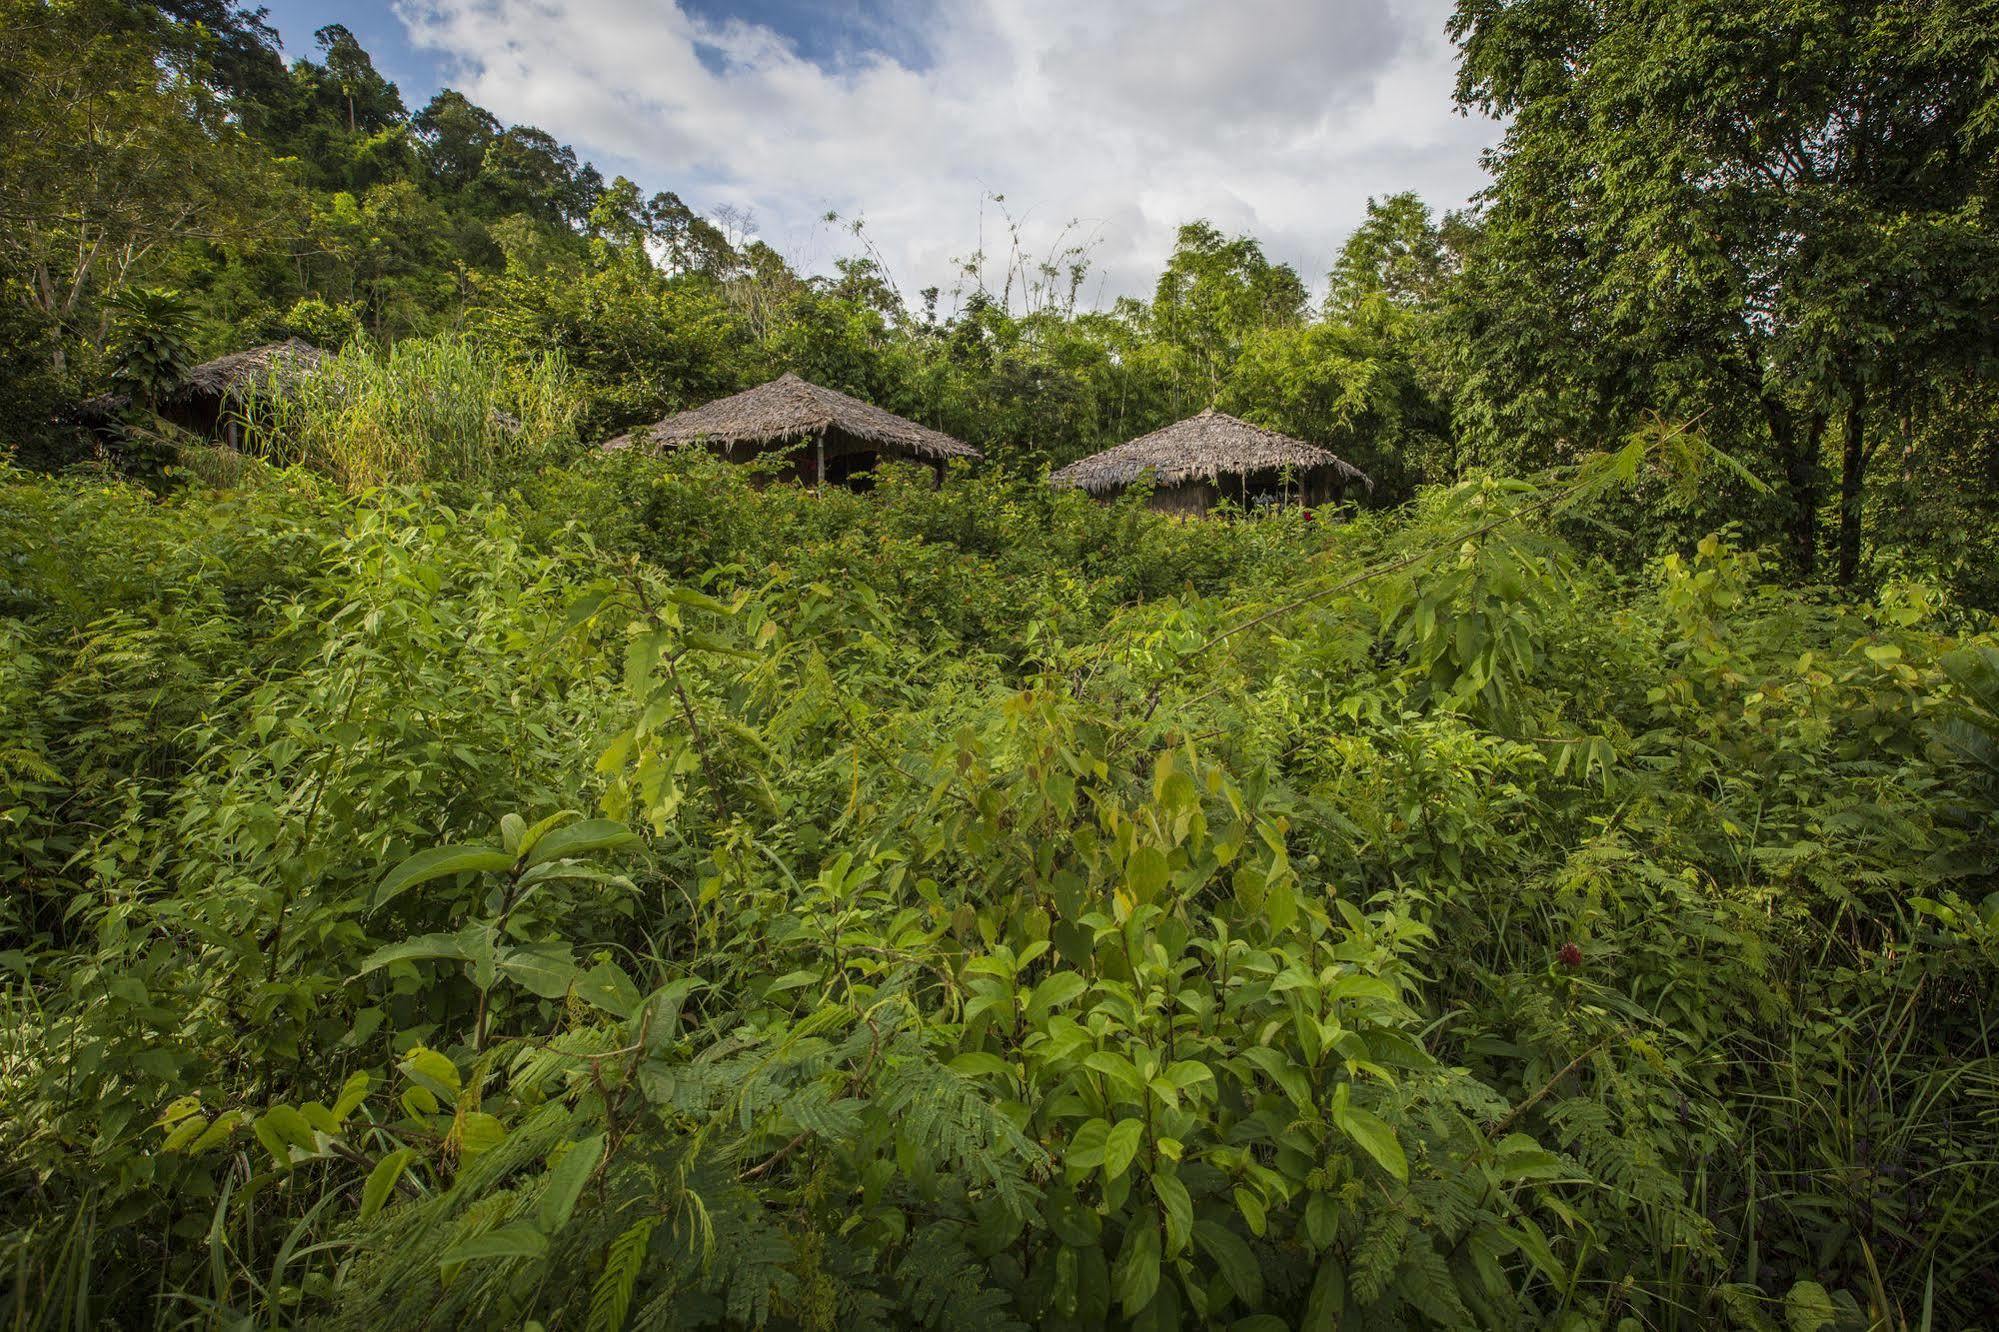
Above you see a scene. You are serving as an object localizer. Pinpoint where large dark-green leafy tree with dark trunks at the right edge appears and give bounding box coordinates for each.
[1451,0,1999,580]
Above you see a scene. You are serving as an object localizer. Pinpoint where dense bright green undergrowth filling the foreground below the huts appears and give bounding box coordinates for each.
[0,434,1999,1332]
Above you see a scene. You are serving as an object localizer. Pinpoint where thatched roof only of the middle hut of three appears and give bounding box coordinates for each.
[604,374,982,460]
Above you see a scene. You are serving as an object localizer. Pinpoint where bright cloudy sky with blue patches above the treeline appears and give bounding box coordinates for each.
[257,0,1495,302]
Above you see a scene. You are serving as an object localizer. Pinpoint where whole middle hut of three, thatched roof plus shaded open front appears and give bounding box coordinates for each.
[604,374,982,488]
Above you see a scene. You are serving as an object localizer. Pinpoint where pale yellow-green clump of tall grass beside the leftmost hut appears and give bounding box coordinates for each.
[242,336,576,490]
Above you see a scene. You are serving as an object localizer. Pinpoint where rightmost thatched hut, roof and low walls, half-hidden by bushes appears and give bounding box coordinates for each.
[1047,408,1373,514]
